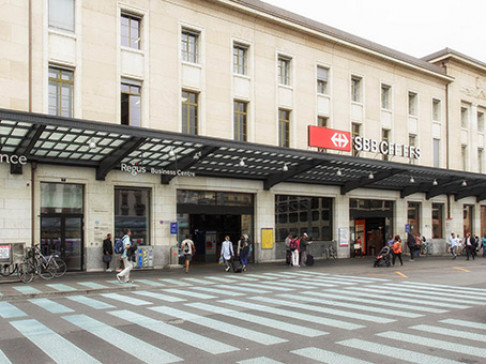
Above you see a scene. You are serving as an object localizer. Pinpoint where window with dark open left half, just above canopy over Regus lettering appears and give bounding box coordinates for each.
[121,80,142,126]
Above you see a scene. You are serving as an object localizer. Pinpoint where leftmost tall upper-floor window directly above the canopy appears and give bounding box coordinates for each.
[48,67,74,118]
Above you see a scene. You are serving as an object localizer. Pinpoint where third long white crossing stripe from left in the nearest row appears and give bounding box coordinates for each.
[110,310,240,354]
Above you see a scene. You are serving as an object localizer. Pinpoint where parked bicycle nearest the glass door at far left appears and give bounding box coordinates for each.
[17,245,67,283]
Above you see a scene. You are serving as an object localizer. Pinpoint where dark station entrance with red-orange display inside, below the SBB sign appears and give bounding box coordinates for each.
[349,199,394,256]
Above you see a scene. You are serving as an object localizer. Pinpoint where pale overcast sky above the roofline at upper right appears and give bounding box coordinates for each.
[264,0,486,63]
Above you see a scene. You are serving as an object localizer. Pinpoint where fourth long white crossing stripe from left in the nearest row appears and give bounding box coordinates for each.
[149,306,287,345]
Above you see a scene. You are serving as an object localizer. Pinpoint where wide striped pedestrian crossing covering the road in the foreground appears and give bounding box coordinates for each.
[0,271,486,364]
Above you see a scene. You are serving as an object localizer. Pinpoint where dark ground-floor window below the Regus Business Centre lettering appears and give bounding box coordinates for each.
[115,187,150,245]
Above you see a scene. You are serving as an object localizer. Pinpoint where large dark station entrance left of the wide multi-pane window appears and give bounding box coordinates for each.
[177,190,254,263]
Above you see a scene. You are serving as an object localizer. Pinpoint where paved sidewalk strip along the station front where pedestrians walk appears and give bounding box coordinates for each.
[0,256,486,301]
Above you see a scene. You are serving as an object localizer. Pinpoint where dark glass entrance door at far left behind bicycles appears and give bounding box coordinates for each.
[41,214,84,271]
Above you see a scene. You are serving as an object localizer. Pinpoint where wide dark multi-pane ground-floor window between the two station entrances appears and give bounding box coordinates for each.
[275,195,333,242]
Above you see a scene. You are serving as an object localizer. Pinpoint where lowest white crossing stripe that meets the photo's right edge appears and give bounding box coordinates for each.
[376,331,486,359]
